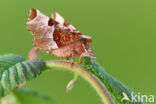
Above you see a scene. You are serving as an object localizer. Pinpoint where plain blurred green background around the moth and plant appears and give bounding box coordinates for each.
[0,0,156,104]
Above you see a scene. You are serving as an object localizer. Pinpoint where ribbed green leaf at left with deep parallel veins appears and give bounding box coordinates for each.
[0,54,44,97]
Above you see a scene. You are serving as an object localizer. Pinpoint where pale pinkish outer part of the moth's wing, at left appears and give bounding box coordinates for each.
[26,9,58,52]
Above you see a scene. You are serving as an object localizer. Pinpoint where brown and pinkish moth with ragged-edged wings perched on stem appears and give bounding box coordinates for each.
[26,9,93,59]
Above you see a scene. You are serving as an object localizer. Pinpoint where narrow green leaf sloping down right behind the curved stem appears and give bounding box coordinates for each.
[81,57,143,104]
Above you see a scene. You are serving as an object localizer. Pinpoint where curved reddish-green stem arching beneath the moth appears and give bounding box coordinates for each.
[46,61,113,104]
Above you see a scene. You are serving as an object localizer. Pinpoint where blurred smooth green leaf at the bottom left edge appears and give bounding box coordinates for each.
[1,89,53,104]
